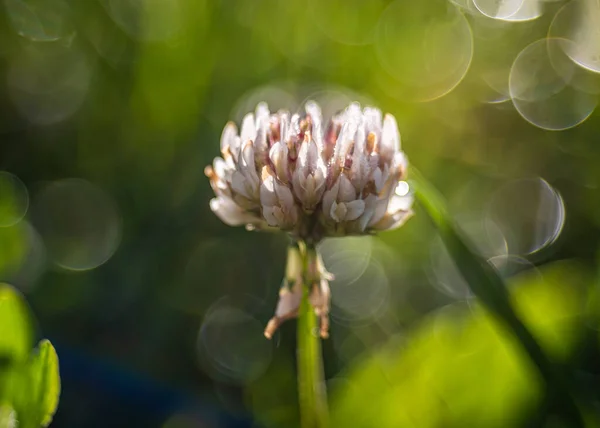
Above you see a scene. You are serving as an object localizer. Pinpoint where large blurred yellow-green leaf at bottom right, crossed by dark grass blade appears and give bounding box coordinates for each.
[332,262,587,428]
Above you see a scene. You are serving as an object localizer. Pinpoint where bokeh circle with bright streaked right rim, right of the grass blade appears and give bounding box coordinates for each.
[486,178,566,256]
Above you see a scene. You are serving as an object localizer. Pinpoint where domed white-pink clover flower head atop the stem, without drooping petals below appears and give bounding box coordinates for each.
[205,101,412,242]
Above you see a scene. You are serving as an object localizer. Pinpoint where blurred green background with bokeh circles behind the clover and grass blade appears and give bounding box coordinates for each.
[0,0,600,428]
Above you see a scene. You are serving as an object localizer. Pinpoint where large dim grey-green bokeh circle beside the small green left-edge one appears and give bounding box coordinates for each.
[32,178,121,270]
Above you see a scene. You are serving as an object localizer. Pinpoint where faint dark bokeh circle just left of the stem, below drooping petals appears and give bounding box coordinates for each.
[197,297,273,384]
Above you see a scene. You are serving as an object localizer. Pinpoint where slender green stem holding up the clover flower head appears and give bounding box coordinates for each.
[297,245,327,428]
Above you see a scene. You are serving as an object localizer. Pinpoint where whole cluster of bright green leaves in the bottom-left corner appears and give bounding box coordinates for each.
[0,284,60,428]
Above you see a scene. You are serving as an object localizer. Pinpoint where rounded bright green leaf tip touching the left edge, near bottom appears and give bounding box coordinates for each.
[0,283,33,362]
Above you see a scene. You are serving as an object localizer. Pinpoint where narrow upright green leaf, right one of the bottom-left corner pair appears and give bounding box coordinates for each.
[28,339,60,427]
